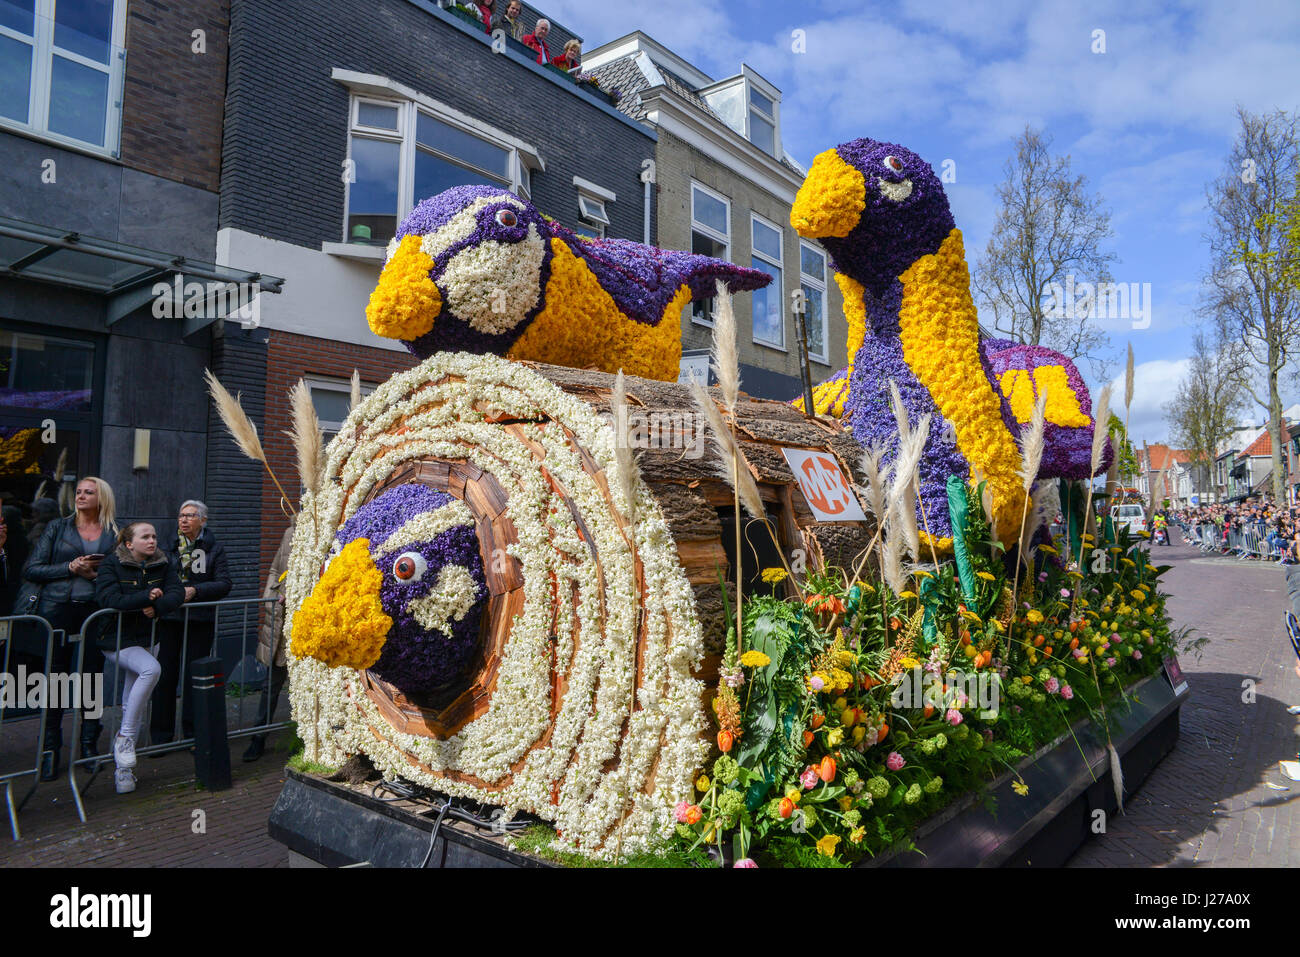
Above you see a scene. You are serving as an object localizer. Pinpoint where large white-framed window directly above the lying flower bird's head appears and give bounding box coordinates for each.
[343,92,536,246]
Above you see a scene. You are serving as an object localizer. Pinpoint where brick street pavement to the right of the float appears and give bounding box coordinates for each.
[1067,531,1300,867]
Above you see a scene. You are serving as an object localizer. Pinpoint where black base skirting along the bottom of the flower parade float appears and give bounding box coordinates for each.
[268,674,1188,867]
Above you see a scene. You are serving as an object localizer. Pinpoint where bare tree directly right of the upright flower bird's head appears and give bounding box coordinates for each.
[974,126,1115,365]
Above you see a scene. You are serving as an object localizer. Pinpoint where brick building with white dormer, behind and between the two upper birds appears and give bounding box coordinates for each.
[582,31,848,399]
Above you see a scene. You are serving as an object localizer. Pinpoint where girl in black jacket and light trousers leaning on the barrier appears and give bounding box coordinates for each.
[95,521,185,794]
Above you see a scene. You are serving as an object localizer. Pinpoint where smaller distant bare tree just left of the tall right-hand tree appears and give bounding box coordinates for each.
[1165,332,1248,489]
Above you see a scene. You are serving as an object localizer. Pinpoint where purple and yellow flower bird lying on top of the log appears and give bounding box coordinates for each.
[365,186,771,381]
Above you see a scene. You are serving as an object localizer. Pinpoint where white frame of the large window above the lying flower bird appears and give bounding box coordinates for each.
[335,87,543,243]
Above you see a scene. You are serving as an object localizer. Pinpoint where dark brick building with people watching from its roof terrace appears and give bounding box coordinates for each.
[217,0,655,595]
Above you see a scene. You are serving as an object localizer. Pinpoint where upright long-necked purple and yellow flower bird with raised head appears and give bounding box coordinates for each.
[790,139,1107,549]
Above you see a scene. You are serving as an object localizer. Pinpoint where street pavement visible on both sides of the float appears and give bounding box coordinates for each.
[0,533,1300,867]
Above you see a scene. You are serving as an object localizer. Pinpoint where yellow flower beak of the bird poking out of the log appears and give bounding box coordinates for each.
[289,538,393,670]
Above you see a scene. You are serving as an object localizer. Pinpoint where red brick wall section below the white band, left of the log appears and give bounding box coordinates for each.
[260,330,417,577]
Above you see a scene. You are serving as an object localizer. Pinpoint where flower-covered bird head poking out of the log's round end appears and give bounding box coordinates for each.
[291,484,488,701]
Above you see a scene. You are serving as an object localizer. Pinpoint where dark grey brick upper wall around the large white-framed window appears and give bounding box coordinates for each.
[221,0,654,248]
